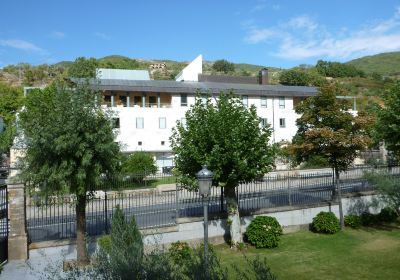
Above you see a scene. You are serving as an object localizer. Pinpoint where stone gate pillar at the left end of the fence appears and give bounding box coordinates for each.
[7,179,28,260]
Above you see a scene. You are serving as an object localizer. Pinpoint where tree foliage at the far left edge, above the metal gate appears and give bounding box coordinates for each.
[0,83,23,155]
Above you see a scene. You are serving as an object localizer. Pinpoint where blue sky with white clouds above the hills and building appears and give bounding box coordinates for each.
[0,0,400,68]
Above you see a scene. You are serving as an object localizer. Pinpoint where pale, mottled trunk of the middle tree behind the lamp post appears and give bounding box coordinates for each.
[224,186,243,246]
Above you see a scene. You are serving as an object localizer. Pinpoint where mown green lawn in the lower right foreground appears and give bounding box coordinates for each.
[216,227,400,280]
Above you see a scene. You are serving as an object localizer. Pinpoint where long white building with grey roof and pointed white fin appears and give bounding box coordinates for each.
[86,56,317,169]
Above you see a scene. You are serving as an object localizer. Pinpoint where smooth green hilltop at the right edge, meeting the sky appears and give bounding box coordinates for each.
[347,52,400,76]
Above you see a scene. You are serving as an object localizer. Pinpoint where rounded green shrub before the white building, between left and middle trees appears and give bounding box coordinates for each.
[121,151,157,176]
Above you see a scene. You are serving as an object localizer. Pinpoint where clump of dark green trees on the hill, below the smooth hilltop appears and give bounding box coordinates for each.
[315,60,365,78]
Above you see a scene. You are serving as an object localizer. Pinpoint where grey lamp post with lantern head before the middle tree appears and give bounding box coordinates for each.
[196,165,214,274]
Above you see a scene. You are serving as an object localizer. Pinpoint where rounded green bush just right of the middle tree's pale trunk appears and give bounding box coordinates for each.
[245,216,282,248]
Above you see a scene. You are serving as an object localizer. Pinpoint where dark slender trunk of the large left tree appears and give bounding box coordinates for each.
[76,195,89,264]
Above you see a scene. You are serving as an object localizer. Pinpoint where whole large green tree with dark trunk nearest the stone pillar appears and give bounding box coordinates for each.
[20,84,119,262]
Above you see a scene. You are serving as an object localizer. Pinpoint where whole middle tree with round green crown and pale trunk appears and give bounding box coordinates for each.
[171,93,274,244]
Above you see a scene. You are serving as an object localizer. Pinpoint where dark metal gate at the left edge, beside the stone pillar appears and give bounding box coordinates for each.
[0,185,8,264]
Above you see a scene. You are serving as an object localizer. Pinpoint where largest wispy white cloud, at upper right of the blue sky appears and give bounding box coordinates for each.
[244,7,400,60]
